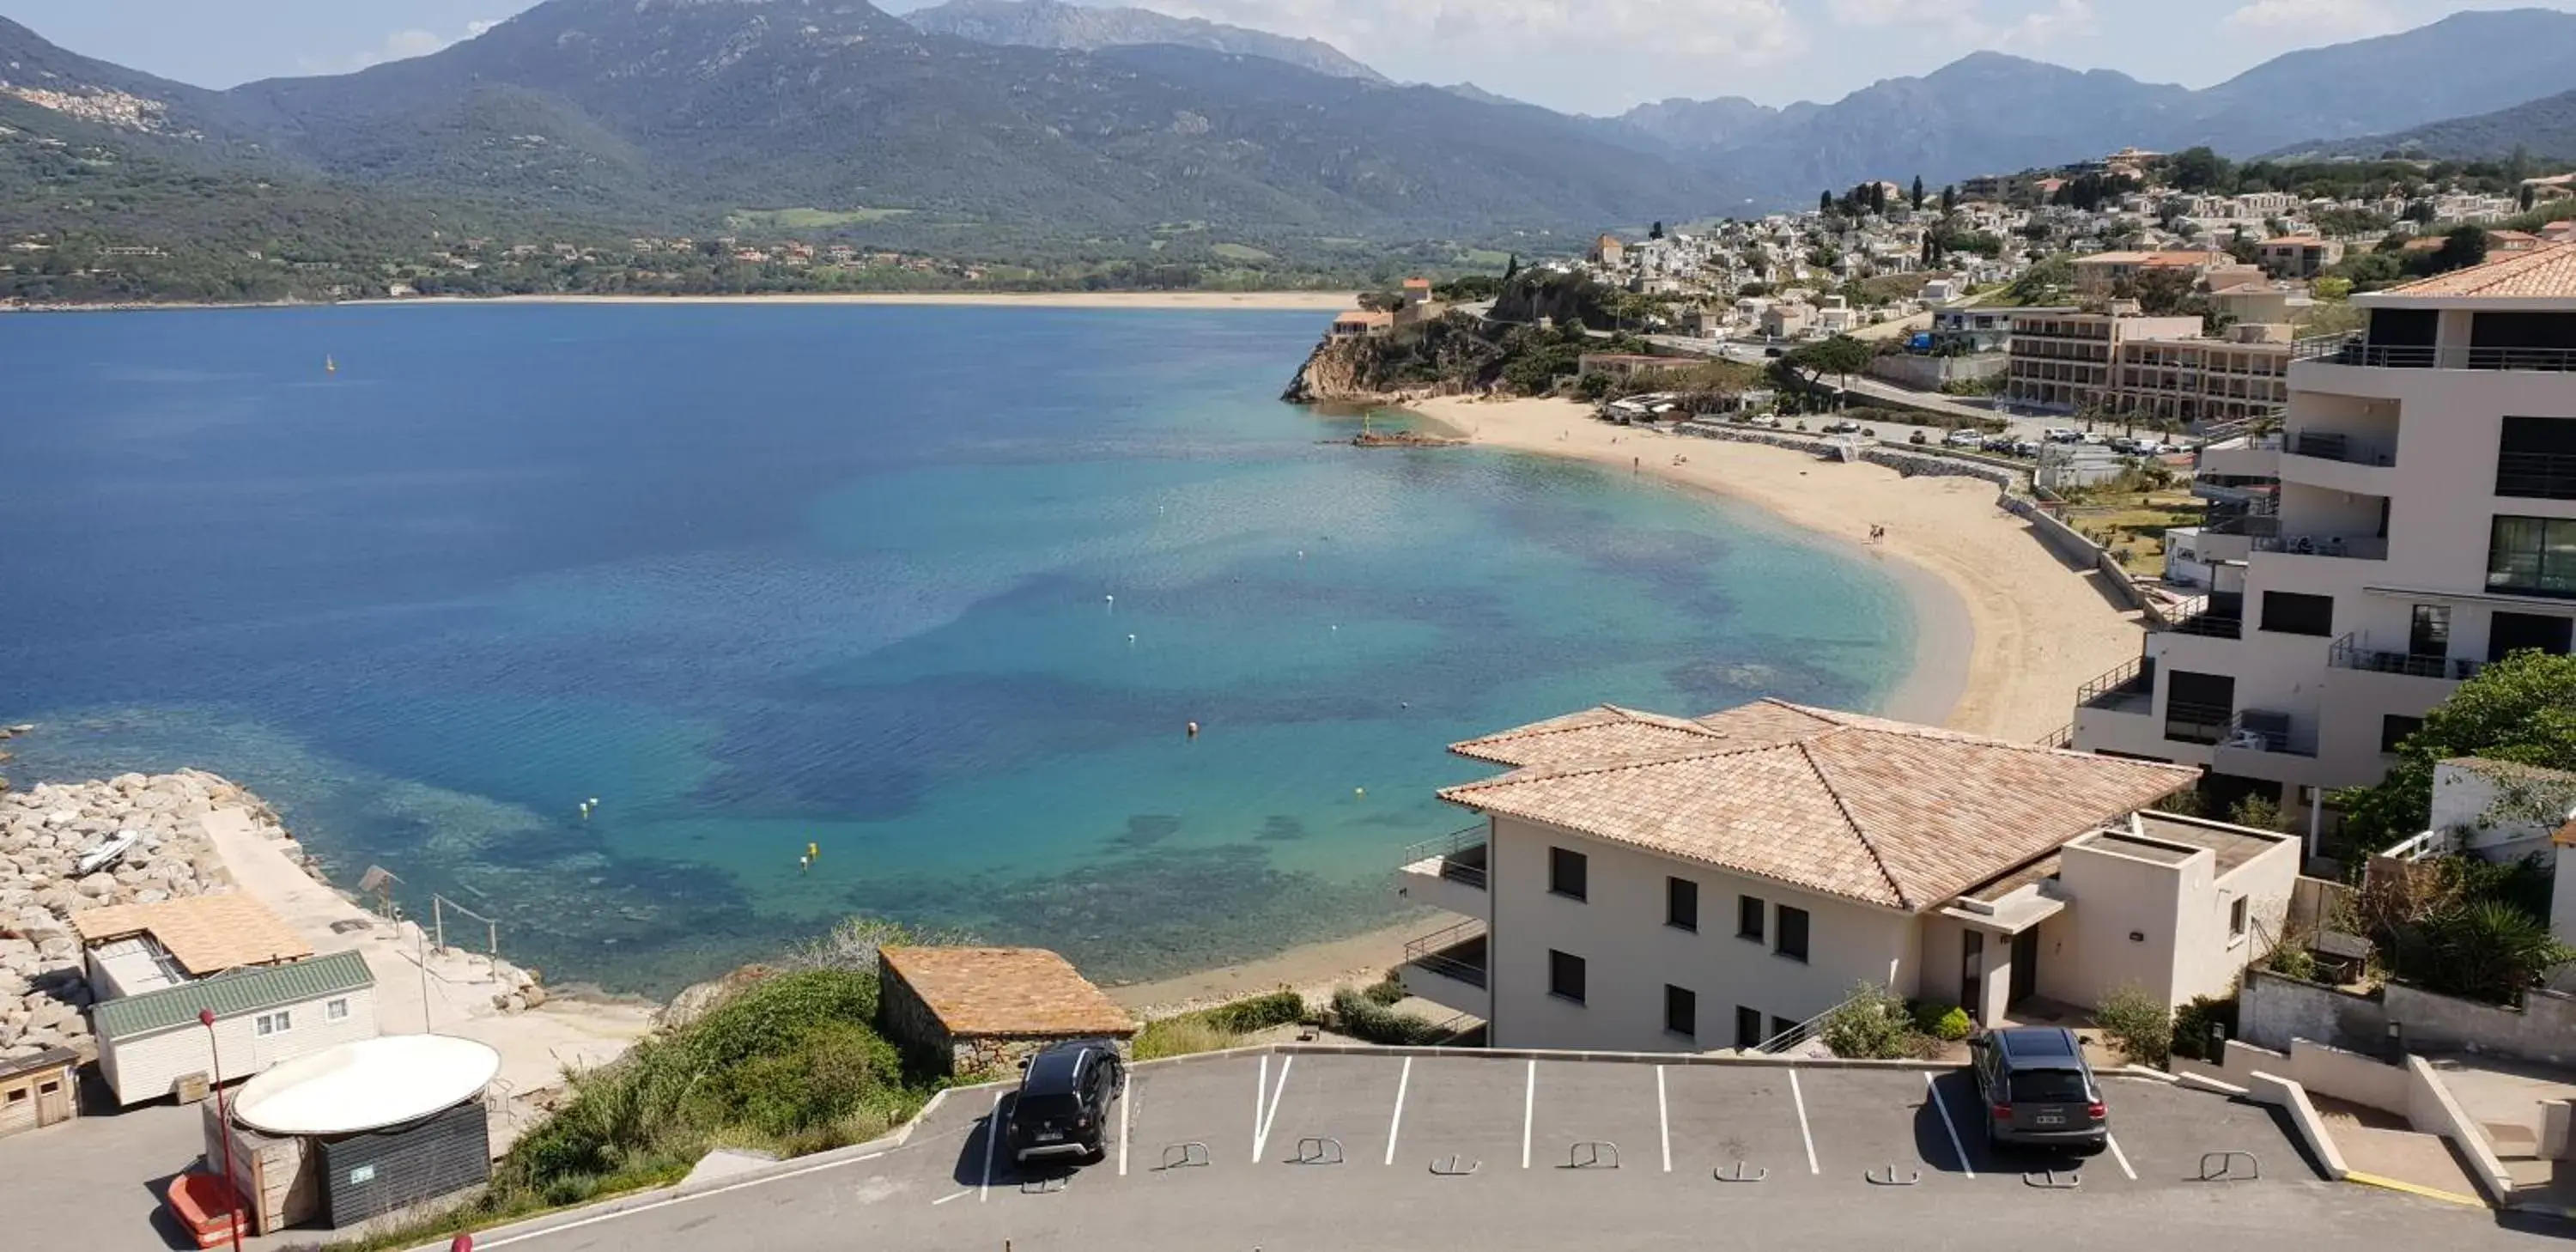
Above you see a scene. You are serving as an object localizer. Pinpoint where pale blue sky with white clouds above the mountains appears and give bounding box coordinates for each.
[0,0,2576,113]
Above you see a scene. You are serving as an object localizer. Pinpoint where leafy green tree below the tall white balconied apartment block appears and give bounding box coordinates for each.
[2334,652,2576,848]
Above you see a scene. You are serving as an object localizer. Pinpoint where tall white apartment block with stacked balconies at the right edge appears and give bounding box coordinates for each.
[2074,245,2576,806]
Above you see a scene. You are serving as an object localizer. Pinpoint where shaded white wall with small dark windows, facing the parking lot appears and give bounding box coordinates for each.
[1486,817,1917,1051]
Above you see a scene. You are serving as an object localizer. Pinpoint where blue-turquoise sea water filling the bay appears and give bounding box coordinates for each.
[0,307,1911,992]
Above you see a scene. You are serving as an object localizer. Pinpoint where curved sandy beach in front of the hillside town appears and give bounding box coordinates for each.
[1417,397,2143,739]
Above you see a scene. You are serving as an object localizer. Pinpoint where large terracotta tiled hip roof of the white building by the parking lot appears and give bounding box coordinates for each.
[1440,701,2197,912]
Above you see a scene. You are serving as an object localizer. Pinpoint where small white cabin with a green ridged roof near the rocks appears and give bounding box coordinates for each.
[90,953,376,1105]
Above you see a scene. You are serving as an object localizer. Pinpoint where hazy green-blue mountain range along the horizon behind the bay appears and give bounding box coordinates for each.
[0,0,2576,266]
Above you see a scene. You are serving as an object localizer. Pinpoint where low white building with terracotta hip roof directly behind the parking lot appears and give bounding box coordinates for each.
[1396,701,2298,1051]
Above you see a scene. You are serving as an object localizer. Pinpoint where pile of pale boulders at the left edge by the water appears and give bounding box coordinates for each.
[0,770,258,1059]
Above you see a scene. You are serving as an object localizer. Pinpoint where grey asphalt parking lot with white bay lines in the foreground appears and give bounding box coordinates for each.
[482,1051,2555,1252]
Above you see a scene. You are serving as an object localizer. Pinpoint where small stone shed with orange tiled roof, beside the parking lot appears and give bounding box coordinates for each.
[876,948,1136,1074]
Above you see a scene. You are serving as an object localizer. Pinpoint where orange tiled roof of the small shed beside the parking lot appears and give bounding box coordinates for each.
[876,948,1136,1038]
